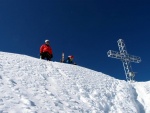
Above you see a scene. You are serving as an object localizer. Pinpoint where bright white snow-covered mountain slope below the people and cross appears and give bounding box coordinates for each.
[0,52,150,113]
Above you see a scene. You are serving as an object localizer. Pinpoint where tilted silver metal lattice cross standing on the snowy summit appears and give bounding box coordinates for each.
[107,39,141,81]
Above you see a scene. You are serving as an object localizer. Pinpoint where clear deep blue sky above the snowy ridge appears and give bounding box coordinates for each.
[0,0,150,81]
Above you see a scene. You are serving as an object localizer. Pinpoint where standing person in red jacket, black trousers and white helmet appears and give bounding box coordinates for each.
[40,40,53,61]
